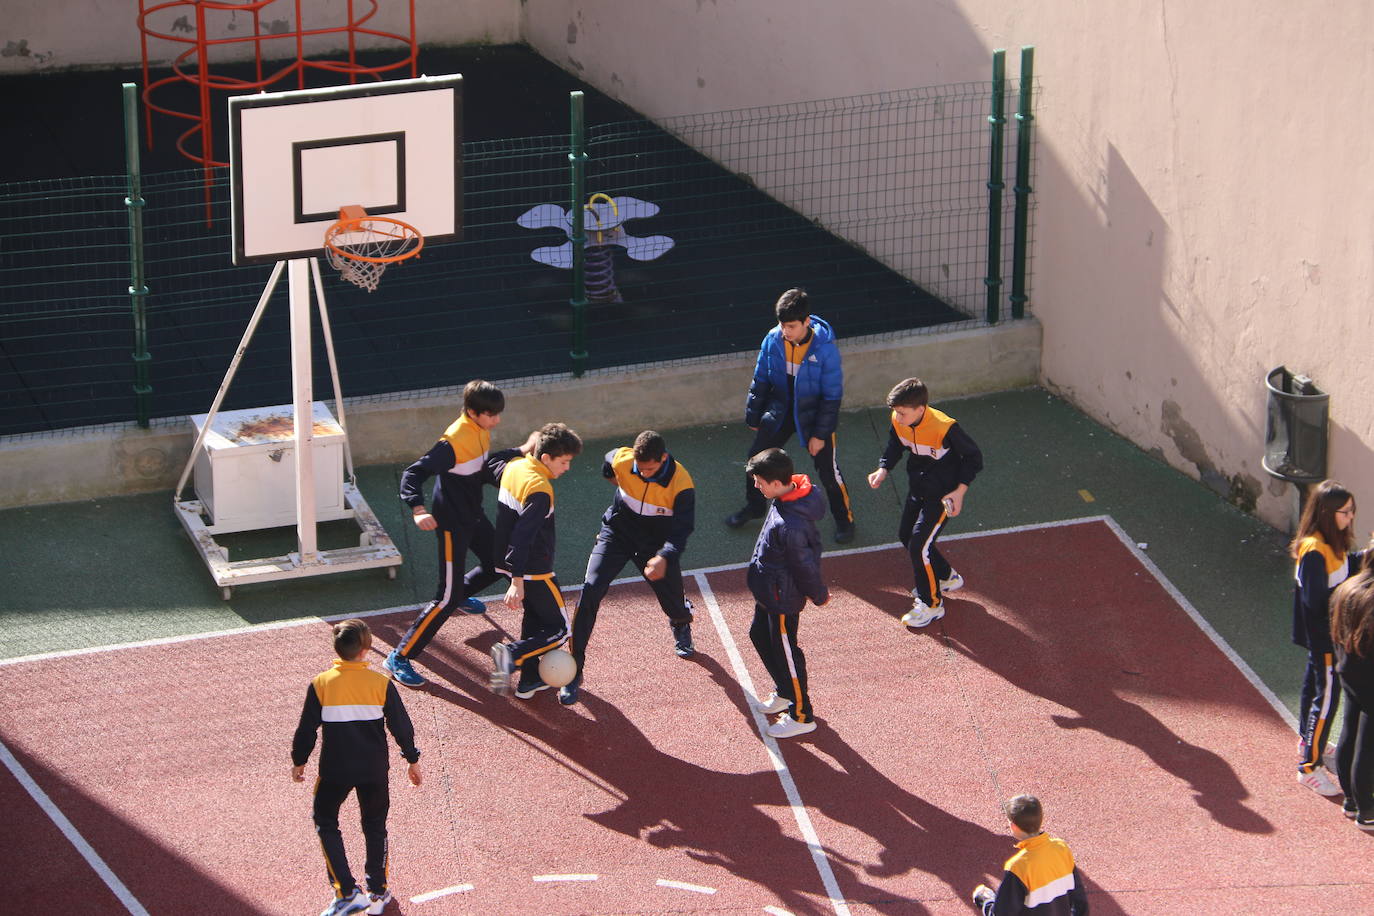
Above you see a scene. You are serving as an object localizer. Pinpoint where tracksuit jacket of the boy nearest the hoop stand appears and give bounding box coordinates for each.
[401,411,518,530]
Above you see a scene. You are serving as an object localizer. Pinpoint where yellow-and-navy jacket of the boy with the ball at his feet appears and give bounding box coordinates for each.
[493,455,554,578]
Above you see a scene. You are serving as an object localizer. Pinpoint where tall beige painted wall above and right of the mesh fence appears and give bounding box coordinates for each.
[523,0,1374,533]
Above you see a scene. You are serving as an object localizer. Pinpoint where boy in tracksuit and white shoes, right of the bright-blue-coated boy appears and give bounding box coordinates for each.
[868,379,982,626]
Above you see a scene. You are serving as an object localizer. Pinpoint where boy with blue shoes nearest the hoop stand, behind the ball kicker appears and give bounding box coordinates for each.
[383,379,529,687]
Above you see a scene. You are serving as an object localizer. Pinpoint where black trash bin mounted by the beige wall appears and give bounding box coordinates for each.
[1263,365,1330,483]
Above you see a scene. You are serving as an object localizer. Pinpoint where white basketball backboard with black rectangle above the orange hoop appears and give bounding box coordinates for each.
[229,74,463,264]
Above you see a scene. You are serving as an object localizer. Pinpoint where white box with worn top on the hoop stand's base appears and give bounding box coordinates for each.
[191,401,352,534]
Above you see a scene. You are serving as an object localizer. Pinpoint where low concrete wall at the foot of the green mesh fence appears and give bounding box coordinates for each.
[0,320,1040,508]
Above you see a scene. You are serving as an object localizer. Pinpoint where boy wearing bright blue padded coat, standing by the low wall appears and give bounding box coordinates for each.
[725,288,855,544]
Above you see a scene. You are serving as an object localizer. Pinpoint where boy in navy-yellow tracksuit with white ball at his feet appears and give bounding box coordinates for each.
[491,423,583,699]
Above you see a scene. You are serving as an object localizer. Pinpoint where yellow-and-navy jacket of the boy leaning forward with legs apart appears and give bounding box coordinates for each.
[602,448,697,559]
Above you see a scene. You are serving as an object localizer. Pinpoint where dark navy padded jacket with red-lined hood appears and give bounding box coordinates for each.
[749,474,830,614]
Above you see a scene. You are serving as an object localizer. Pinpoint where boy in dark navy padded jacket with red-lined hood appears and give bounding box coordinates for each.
[745,449,830,737]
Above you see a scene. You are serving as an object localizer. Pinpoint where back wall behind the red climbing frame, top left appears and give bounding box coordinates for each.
[0,0,522,76]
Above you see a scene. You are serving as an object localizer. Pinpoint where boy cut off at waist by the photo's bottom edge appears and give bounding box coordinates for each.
[973,795,1088,916]
